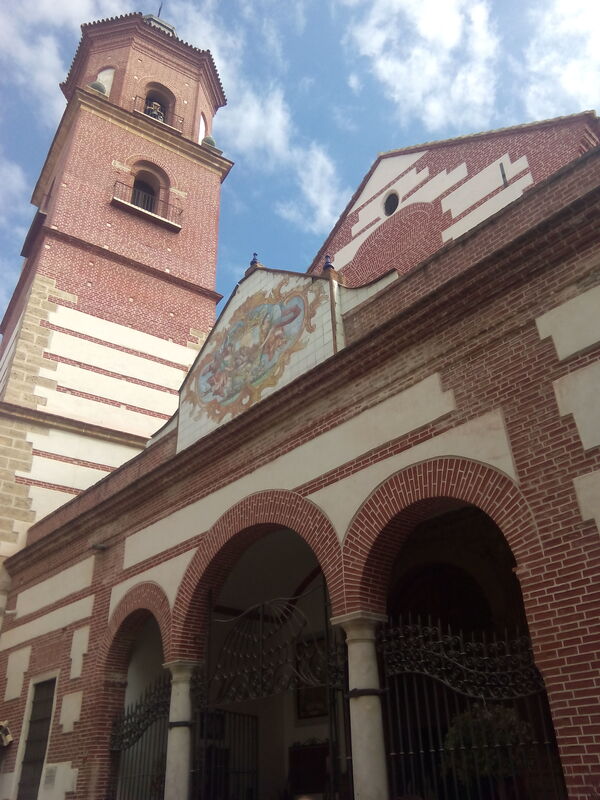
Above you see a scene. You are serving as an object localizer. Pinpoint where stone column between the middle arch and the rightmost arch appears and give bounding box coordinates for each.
[331,611,389,800]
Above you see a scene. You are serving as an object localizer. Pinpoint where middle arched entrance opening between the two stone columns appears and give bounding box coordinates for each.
[192,530,351,800]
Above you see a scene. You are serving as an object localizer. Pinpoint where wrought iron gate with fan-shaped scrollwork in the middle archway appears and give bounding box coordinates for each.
[191,595,351,800]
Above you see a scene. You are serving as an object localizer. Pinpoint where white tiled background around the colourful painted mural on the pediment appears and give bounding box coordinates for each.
[177,269,334,451]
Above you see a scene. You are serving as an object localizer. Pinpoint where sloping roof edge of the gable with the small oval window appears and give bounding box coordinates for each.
[307,109,600,274]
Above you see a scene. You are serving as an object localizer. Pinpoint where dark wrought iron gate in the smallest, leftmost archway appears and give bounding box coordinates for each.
[108,675,171,800]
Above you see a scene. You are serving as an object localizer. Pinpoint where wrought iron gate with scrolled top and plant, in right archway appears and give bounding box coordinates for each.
[379,621,567,800]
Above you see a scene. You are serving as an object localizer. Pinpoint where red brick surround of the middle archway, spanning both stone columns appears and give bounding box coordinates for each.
[172,489,343,659]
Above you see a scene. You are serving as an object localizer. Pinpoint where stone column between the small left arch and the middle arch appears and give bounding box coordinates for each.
[163,661,198,800]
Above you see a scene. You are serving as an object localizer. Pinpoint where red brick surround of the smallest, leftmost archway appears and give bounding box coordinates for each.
[97,582,171,675]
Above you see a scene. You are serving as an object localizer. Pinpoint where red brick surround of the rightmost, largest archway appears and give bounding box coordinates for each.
[342,457,542,613]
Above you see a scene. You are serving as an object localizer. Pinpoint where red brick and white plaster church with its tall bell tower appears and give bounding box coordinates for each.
[0,14,600,800]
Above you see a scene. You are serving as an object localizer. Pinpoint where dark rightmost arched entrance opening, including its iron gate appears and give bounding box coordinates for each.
[379,506,567,800]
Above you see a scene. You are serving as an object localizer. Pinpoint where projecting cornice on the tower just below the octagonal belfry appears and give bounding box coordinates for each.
[31,89,233,208]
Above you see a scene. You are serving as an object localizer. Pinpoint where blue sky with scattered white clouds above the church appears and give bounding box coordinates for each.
[0,0,600,313]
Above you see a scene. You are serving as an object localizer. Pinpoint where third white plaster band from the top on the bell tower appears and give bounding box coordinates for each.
[40,363,179,414]
